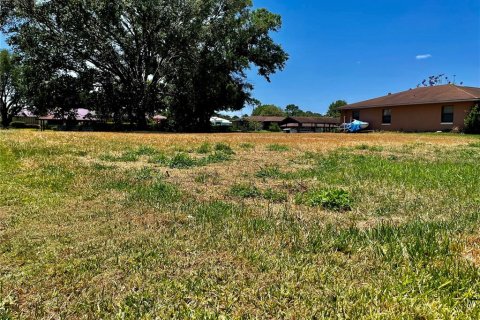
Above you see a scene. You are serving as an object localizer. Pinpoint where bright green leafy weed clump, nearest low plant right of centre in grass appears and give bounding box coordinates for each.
[296,189,352,211]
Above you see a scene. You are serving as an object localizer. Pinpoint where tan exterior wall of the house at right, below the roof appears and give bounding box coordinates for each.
[341,102,475,132]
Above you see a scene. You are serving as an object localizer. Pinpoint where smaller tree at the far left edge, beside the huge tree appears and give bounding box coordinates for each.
[0,50,23,128]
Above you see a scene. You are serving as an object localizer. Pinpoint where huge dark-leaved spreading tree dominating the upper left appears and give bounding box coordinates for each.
[0,0,288,131]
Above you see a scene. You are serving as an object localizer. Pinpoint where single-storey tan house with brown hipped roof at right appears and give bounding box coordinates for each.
[339,84,480,132]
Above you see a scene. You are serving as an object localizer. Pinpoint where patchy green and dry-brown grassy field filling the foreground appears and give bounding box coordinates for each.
[0,130,480,319]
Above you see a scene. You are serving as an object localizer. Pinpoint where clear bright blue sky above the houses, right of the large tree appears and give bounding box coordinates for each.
[0,0,480,112]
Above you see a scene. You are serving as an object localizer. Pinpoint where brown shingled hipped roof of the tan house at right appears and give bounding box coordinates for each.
[338,84,480,110]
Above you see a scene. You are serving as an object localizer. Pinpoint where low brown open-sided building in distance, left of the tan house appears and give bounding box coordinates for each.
[280,117,340,133]
